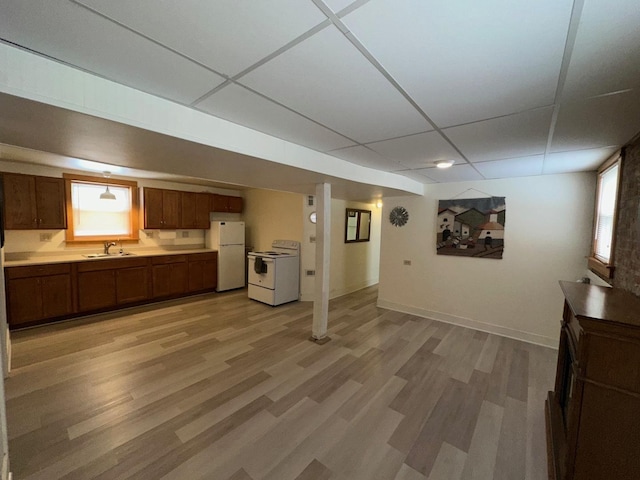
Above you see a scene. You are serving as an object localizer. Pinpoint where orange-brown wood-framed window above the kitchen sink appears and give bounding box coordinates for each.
[65,175,138,242]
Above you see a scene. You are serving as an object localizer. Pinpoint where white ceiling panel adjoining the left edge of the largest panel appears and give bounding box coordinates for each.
[240,26,429,143]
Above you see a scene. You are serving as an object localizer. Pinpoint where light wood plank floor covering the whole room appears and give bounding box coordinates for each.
[6,287,556,480]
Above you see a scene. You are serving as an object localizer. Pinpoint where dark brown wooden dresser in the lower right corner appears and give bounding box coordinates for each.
[546,282,640,480]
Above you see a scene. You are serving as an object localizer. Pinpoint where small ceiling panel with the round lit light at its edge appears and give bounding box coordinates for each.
[367,132,464,168]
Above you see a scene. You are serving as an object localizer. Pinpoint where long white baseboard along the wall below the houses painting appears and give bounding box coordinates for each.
[377,298,559,350]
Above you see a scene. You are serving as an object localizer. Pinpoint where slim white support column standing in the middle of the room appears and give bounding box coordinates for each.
[309,183,331,344]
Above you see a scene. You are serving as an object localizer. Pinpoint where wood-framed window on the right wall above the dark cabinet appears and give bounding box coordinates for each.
[589,154,620,279]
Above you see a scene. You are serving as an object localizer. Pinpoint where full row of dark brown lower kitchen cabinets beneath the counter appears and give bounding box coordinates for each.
[5,252,218,328]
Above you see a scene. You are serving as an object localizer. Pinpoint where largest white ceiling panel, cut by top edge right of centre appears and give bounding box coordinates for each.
[343,0,573,127]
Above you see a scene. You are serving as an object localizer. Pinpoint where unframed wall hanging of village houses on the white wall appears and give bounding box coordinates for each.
[436,197,506,259]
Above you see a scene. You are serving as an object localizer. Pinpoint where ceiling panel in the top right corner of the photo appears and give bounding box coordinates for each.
[563,0,640,99]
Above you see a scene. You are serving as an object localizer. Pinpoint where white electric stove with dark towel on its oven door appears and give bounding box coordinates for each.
[247,240,300,306]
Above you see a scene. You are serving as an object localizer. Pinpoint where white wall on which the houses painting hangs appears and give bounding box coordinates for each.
[378,173,595,347]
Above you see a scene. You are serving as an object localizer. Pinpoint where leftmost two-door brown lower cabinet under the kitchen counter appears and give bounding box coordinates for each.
[5,263,73,327]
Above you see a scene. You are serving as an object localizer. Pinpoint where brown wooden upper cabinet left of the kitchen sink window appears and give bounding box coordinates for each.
[3,173,67,230]
